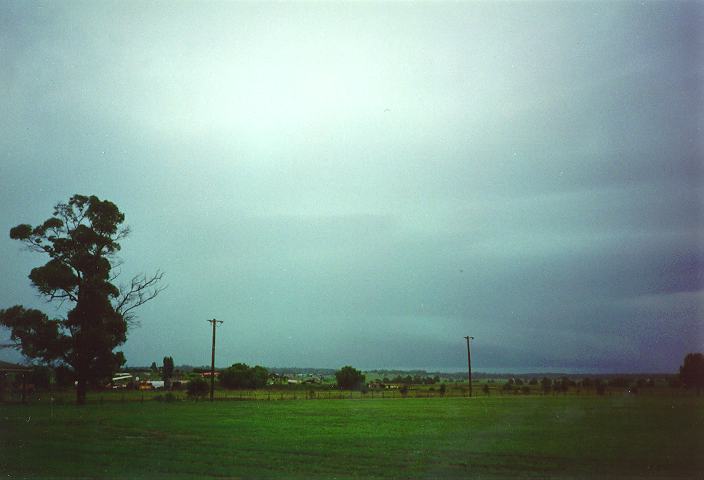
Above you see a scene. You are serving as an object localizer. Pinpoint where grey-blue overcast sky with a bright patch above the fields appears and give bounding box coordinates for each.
[0,1,704,372]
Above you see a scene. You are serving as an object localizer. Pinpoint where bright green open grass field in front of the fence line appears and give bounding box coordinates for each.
[0,396,704,478]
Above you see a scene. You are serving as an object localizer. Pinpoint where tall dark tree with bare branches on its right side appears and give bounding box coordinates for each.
[0,195,163,404]
